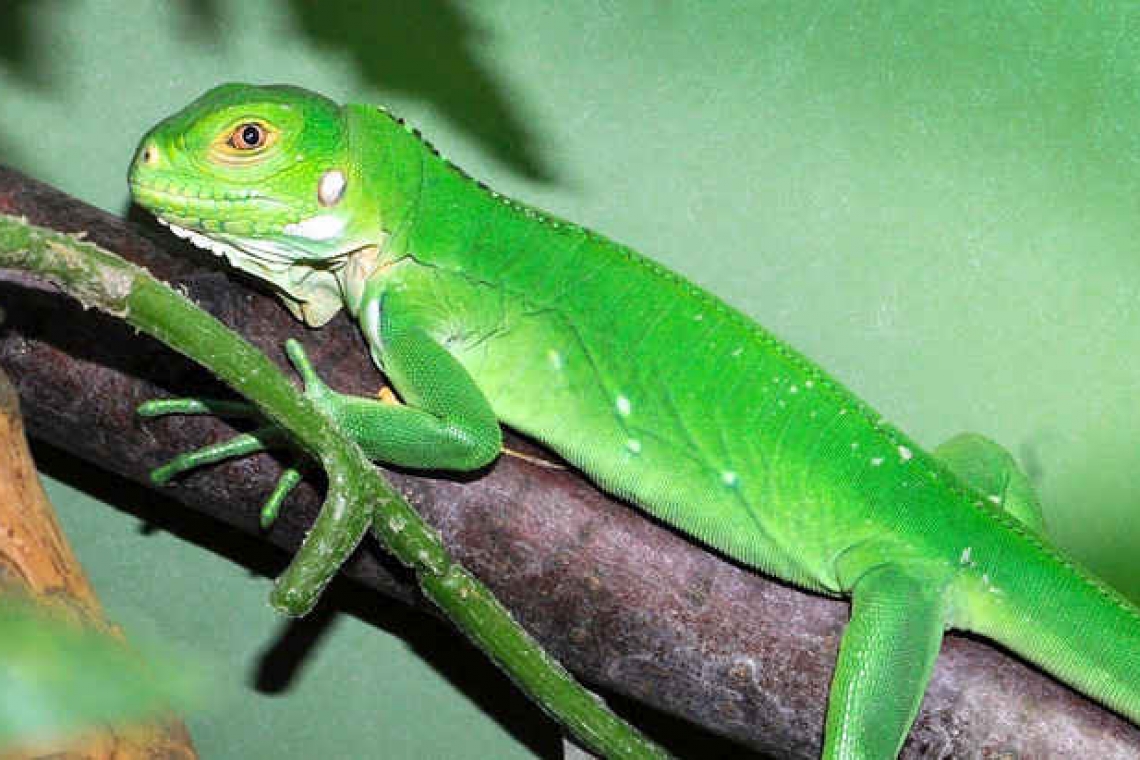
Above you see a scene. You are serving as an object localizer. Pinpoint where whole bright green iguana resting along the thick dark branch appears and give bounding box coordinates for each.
[130,84,1140,758]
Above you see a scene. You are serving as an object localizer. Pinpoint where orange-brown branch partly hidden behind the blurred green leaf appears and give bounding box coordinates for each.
[0,373,197,760]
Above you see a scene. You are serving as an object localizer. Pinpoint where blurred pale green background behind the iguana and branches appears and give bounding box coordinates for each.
[0,0,1140,759]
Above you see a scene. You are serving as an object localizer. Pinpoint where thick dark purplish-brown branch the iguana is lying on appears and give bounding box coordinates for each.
[0,170,1140,758]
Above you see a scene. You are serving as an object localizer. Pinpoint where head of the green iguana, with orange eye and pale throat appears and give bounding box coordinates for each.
[129,84,381,325]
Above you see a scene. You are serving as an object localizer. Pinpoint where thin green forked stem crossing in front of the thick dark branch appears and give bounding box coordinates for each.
[0,214,668,758]
